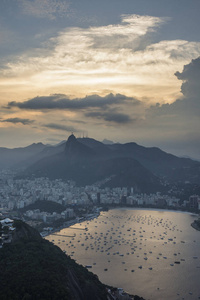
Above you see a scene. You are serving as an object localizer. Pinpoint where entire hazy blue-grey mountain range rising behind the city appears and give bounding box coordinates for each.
[1,135,200,193]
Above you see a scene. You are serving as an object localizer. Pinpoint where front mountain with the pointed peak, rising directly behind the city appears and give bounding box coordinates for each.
[17,135,161,192]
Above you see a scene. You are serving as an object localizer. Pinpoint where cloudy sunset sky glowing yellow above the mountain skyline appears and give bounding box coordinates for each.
[0,0,200,159]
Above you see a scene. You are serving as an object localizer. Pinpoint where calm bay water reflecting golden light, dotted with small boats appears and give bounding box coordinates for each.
[47,208,200,300]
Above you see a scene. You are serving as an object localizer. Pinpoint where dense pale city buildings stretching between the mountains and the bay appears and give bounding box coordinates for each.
[0,170,200,233]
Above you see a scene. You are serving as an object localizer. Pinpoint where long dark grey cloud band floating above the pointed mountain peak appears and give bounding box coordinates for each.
[7,93,141,125]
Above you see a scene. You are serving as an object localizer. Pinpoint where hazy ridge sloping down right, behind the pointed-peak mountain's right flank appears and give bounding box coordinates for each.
[106,143,200,183]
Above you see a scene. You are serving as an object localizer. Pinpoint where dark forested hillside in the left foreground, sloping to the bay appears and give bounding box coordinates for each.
[0,220,111,300]
